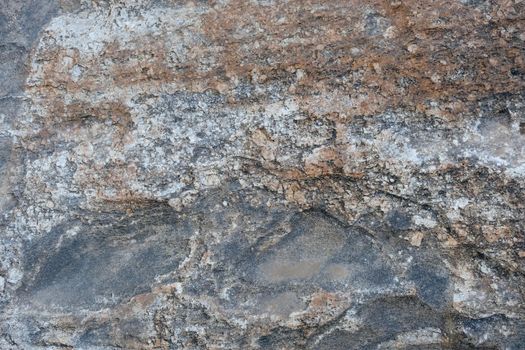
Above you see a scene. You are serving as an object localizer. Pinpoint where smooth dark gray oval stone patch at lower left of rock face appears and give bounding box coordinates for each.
[23,205,192,309]
